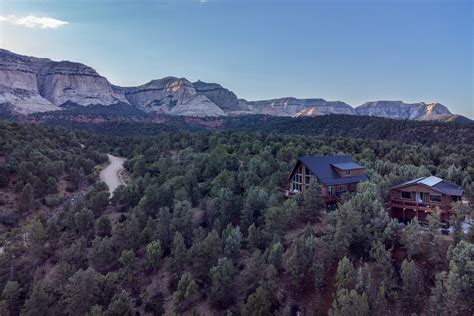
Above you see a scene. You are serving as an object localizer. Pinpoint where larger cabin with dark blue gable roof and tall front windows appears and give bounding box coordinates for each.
[284,155,367,208]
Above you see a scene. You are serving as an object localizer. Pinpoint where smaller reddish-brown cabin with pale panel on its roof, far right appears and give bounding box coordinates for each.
[388,176,464,223]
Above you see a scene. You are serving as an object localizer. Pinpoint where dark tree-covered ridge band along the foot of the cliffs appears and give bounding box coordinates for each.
[20,110,474,145]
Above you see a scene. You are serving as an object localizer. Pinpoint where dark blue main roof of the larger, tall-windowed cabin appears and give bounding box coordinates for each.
[291,155,367,185]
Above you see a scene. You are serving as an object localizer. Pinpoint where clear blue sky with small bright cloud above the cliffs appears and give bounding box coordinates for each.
[0,0,474,118]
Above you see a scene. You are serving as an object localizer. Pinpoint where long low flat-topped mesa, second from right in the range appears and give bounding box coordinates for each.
[247,97,355,117]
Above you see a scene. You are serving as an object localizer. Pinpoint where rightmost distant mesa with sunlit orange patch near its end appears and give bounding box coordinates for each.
[356,101,452,120]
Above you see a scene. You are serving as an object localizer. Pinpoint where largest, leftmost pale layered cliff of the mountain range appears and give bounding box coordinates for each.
[0,49,128,114]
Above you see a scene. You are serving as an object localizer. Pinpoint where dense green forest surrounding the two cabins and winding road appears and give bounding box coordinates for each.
[0,116,474,316]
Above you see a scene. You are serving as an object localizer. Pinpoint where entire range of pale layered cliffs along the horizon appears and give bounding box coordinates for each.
[0,49,469,121]
